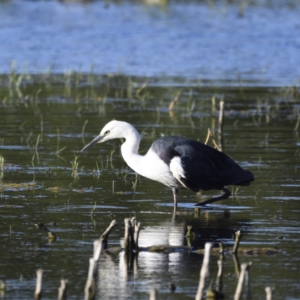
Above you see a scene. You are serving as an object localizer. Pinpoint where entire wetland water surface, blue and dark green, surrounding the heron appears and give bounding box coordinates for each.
[0,0,300,300]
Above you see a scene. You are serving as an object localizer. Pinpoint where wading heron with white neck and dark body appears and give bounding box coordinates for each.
[81,121,254,211]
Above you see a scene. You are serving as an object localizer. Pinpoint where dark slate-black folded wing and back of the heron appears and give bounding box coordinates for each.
[152,136,254,192]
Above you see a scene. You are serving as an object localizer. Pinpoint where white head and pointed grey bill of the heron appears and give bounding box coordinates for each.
[80,120,135,152]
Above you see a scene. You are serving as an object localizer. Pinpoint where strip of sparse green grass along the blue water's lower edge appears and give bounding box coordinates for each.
[0,68,300,132]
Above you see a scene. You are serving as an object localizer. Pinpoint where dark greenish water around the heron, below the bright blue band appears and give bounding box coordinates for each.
[0,77,300,299]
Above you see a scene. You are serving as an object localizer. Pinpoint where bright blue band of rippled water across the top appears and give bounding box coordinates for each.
[0,0,300,86]
